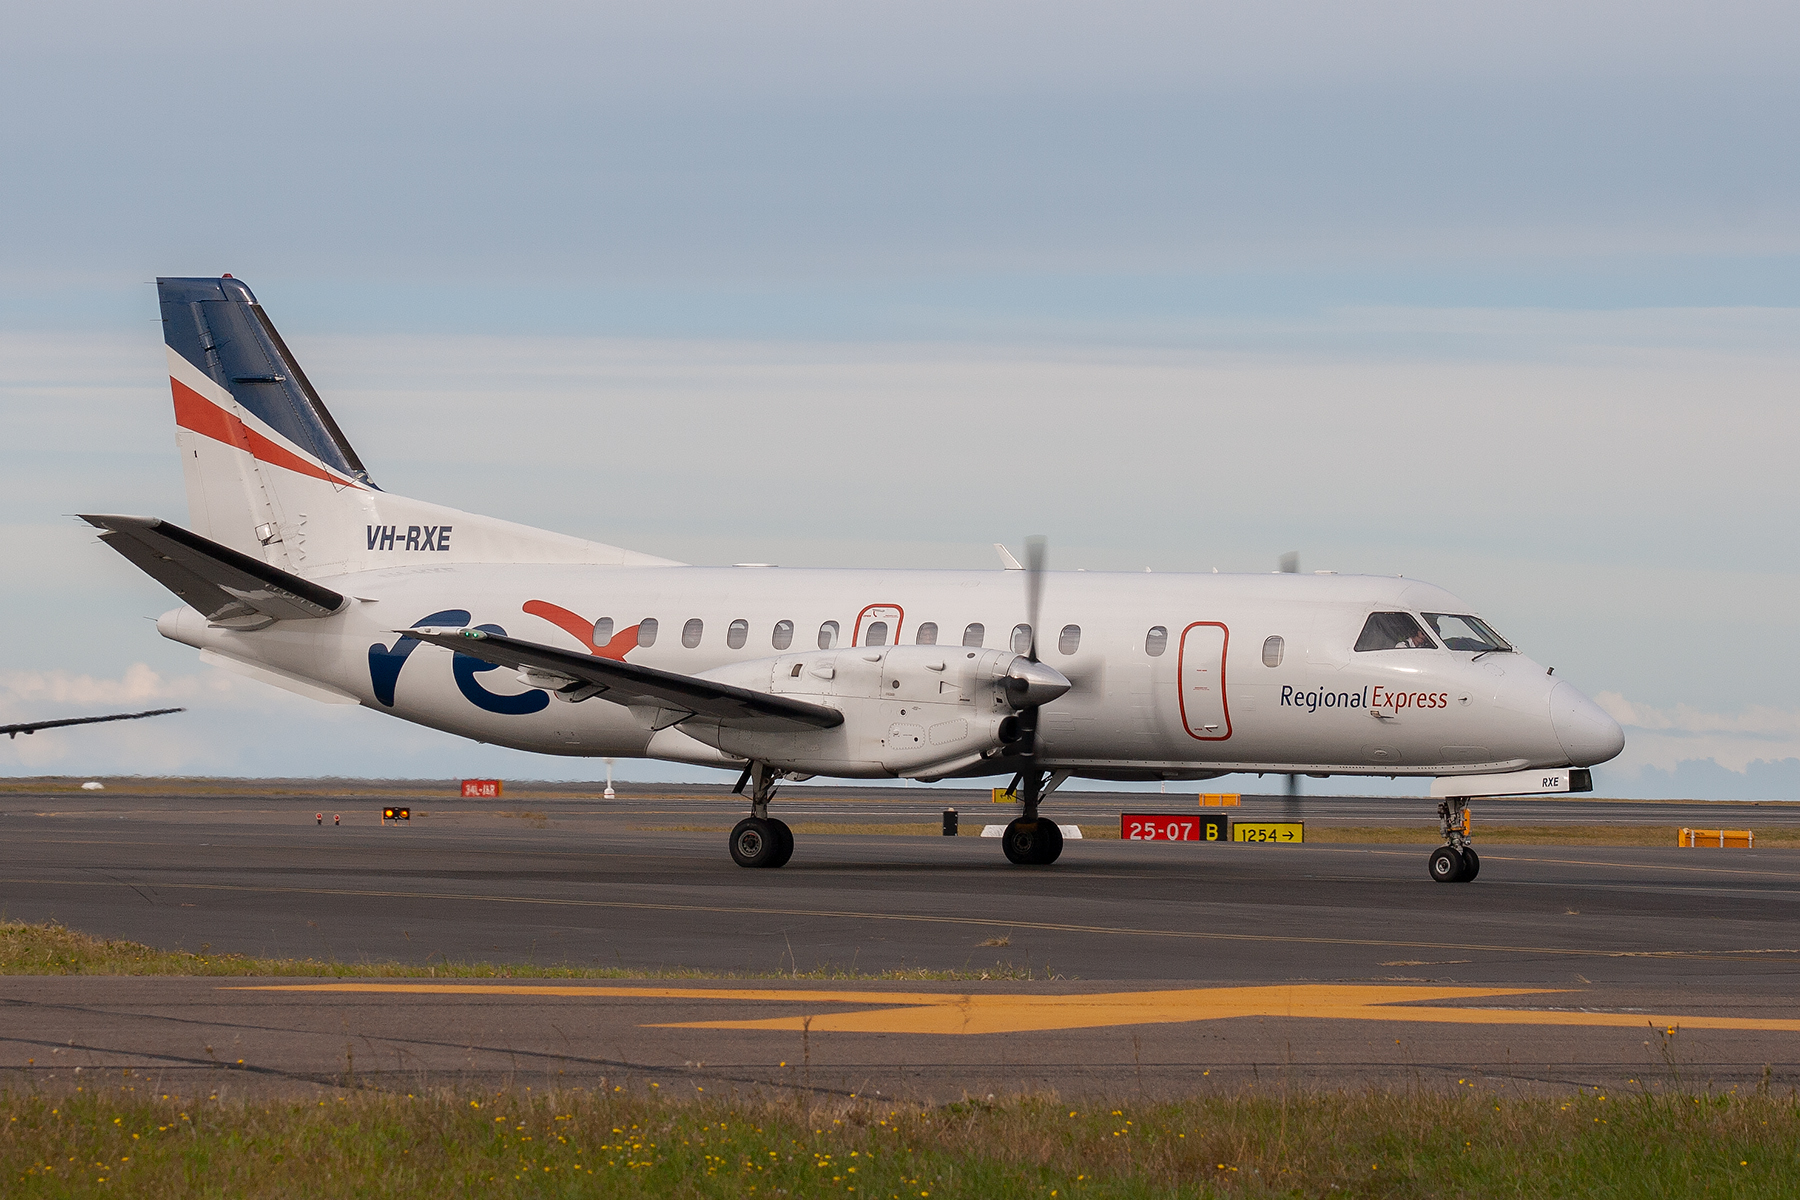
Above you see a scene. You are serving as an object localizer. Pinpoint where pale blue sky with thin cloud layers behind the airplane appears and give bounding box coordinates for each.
[0,0,1800,799]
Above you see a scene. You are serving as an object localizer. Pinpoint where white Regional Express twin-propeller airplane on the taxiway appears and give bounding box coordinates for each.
[83,275,1624,882]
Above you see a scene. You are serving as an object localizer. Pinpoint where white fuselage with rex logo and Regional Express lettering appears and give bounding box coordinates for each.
[158,565,1616,777]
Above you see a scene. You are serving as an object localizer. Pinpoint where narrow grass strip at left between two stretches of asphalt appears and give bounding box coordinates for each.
[0,921,1053,982]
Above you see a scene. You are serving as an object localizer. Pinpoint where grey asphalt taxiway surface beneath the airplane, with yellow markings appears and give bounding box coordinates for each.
[0,781,1800,1099]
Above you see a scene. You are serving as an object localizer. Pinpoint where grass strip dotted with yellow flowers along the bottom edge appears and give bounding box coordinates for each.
[0,1085,1800,1200]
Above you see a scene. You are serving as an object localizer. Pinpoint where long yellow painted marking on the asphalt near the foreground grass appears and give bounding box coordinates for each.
[232,982,1800,1034]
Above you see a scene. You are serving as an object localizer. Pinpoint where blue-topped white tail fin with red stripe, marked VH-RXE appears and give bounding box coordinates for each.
[157,275,671,578]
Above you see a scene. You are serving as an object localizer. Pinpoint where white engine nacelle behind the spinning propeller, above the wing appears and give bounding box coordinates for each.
[680,646,1069,779]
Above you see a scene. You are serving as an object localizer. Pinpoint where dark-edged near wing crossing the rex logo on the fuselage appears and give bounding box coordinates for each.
[396,630,844,732]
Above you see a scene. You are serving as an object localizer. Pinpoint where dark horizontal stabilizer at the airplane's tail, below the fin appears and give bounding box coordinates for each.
[81,515,344,630]
